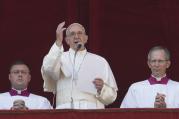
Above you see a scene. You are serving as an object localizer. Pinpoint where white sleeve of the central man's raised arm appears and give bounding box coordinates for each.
[41,43,63,93]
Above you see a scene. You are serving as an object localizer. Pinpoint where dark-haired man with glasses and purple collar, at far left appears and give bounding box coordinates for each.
[0,61,52,110]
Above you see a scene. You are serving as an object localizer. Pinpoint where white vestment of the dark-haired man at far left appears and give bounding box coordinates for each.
[0,92,52,110]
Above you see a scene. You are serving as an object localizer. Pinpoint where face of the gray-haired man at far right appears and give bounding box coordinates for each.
[148,50,171,77]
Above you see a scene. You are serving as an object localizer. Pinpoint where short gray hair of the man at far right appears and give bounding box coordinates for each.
[148,46,170,60]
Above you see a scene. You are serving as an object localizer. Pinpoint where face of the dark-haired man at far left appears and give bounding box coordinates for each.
[9,64,31,90]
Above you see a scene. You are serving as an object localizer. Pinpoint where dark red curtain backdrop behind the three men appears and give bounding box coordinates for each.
[0,0,179,107]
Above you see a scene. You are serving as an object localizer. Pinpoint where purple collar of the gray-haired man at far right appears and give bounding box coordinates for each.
[148,75,169,85]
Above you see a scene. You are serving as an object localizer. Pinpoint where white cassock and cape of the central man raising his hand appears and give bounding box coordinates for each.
[41,44,118,109]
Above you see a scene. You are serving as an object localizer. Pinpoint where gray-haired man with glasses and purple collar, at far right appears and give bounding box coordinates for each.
[121,46,179,108]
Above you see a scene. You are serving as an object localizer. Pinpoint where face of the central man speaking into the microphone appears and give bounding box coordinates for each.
[66,24,88,50]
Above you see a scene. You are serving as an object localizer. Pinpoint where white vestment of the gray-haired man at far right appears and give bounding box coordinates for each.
[120,80,179,108]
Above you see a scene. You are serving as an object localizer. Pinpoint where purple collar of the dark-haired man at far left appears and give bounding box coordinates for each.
[9,88,30,97]
